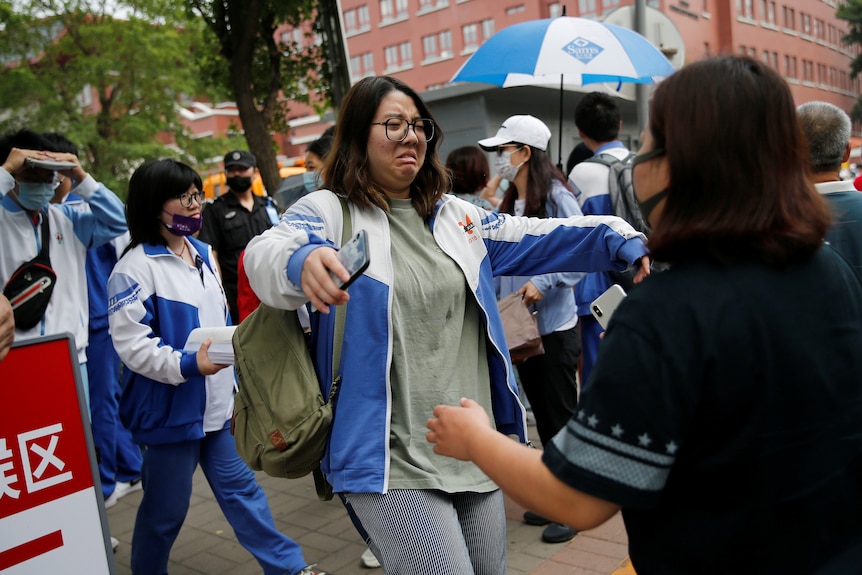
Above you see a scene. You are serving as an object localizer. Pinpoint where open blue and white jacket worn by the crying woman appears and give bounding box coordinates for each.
[244,190,647,493]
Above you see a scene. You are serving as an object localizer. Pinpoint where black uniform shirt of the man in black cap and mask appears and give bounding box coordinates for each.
[198,192,278,323]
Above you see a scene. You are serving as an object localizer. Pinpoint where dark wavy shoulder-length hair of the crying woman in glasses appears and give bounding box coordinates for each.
[322,76,450,219]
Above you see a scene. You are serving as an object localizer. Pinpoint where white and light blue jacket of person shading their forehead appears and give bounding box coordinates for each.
[0,168,128,363]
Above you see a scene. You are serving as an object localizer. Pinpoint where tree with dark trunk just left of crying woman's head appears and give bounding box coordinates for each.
[188,0,331,196]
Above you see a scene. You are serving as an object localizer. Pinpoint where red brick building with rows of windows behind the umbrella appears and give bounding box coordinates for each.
[182,0,860,164]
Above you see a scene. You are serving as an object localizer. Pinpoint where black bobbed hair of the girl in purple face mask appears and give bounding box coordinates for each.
[124,159,203,253]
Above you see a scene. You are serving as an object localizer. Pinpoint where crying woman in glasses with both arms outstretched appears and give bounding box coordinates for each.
[245,77,646,575]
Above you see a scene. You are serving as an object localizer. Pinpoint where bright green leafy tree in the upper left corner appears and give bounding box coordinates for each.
[0,0,230,195]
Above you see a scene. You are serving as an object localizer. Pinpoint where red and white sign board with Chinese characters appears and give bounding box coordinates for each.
[0,334,115,575]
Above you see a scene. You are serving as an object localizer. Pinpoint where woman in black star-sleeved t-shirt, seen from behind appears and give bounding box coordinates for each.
[428,56,862,575]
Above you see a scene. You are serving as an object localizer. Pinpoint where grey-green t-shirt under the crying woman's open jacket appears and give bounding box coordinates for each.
[388,200,497,493]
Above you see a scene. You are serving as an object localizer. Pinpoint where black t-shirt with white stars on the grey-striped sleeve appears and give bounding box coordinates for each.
[543,247,862,575]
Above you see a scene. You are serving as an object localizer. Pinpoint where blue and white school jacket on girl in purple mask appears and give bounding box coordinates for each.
[108,238,235,445]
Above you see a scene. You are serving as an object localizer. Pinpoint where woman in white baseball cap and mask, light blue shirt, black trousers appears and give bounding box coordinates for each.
[479,115,588,543]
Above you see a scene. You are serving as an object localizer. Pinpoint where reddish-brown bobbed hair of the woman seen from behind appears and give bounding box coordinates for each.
[649,56,829,266]
